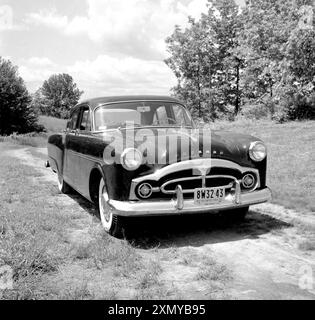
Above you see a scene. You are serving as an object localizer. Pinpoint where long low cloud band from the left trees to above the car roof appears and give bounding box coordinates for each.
[19,55,176,98]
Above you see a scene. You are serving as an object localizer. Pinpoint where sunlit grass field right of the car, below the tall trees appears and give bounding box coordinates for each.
[212,120,315,212]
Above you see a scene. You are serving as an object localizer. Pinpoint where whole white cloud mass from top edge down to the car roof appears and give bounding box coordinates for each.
[19,0,212,98]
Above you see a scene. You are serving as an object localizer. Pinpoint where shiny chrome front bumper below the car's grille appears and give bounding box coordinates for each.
[109,188,272,217]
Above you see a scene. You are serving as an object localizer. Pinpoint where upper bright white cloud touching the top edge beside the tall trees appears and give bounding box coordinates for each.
[26,0,207,60]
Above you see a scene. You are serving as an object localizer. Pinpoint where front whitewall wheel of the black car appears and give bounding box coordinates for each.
[98,178,123,238]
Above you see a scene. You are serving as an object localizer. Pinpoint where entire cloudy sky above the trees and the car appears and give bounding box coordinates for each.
[0,0,244,99]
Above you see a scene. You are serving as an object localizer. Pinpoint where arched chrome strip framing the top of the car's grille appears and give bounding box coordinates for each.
[129,158,260,200]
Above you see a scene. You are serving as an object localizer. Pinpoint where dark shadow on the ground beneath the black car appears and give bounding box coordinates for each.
[66,192,292,249]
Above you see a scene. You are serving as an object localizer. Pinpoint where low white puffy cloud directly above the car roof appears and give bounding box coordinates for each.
[68,55,176,95]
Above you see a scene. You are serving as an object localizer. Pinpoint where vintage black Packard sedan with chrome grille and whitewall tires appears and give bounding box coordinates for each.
[46,96,271,236]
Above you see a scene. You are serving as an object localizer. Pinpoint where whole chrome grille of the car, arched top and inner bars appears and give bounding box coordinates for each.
[129,159,260,201]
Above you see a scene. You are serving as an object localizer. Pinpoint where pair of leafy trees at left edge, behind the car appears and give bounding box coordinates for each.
[0,57,83,135]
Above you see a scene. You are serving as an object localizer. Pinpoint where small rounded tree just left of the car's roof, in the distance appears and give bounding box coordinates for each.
[34,73,83,118]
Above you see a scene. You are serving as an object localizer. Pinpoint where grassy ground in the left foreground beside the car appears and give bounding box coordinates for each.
[0,143,168,300]
